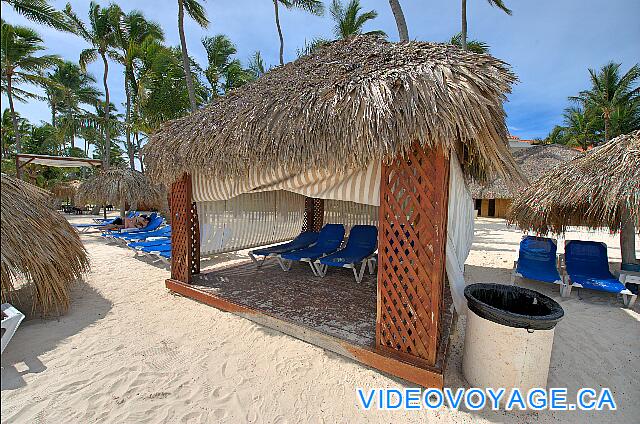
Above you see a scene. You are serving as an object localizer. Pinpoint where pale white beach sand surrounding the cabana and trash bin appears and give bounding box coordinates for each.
[2,217,640,423]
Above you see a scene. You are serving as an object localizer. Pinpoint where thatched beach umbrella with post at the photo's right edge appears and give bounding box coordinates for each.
[509,131,640,263]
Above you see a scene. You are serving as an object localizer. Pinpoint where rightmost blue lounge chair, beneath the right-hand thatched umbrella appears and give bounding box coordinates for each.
[562,240,637,307]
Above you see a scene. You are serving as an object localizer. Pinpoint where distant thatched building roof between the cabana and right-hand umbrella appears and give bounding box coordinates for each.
[469,144,582,199]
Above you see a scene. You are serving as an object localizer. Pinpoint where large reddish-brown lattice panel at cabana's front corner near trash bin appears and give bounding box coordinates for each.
[376,144,449,365]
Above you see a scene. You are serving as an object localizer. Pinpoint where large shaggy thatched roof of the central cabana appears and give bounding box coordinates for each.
[145,35,523,188]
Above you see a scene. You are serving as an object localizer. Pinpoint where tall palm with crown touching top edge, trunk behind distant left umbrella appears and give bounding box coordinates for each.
[65,1,122,169]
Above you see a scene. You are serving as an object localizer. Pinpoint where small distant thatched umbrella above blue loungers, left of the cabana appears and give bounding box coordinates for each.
[77,168,166,217]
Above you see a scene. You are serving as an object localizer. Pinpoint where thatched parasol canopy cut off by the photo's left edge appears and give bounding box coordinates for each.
[1,174,89,315]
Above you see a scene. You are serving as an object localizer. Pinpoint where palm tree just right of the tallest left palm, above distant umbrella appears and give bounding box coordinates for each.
[117,10,164,169]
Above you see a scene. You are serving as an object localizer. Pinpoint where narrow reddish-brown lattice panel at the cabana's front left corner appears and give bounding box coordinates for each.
[170,174,193,283]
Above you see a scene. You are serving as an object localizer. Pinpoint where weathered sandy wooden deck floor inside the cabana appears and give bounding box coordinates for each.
[192,260,376,348]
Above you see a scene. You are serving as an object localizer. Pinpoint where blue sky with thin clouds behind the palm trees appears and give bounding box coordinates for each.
[2,0,640,146]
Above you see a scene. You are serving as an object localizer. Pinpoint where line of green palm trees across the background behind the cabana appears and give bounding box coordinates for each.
[10,0,624,186]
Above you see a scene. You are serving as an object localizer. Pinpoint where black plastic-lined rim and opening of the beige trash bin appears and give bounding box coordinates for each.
[464,283,564,330]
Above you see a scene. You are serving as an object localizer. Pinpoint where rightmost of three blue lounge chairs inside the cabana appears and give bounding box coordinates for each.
[316,225,378,283]
